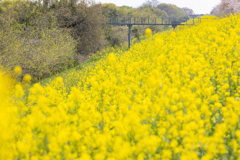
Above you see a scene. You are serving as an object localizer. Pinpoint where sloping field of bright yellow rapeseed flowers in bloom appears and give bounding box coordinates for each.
[0,15,240,160]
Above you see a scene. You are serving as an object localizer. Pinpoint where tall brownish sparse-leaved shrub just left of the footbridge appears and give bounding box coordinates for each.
[55,0,105,55]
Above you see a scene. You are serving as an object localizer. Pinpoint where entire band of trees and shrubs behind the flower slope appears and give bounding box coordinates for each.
[0,0,187,79]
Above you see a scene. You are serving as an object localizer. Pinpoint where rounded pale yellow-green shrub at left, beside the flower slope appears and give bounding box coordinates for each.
[0,21,76,80]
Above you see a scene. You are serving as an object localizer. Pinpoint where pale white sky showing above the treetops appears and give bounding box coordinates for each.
[95,0,221,14]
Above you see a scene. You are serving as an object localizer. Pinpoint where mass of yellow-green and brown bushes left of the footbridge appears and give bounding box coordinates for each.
[0,0,104,80]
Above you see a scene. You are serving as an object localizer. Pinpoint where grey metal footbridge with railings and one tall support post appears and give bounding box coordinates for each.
[105,17,198,48]
